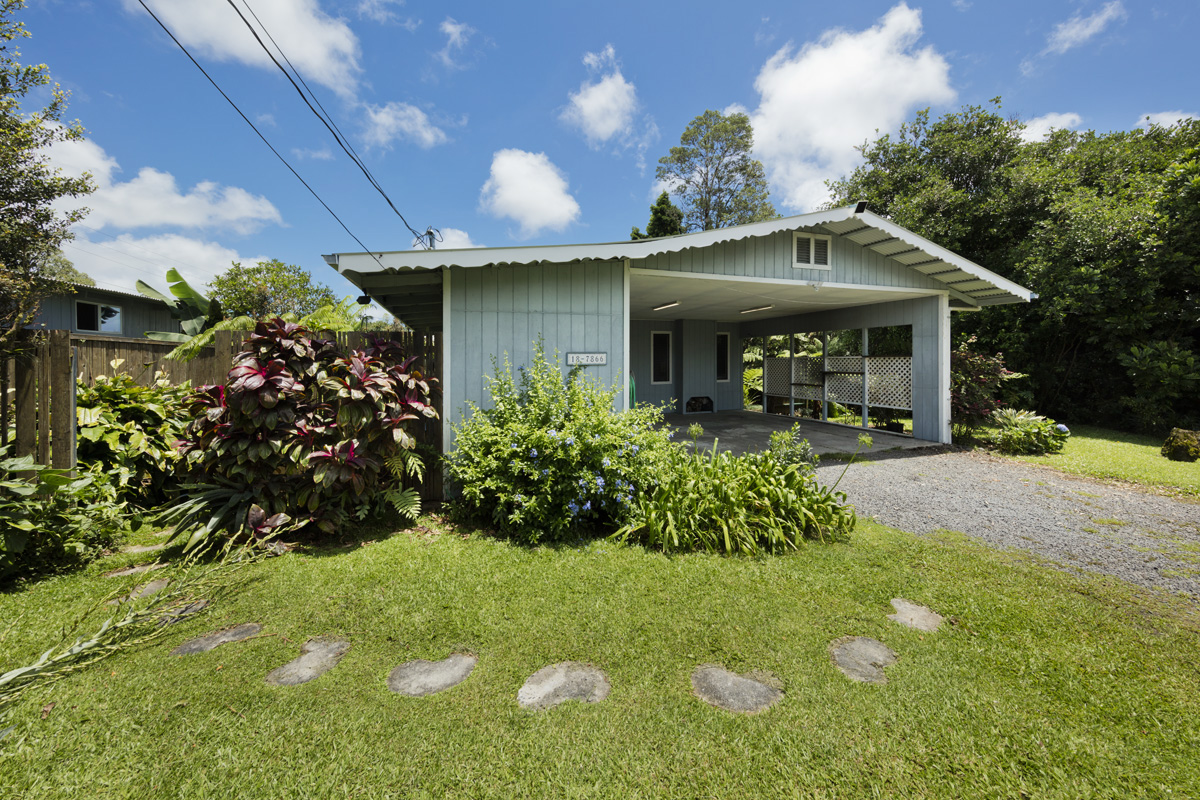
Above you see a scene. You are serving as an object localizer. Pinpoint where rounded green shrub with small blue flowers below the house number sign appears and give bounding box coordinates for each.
[446,343,677,543]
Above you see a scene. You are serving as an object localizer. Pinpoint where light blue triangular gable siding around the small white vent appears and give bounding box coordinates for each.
[630,228,946,290]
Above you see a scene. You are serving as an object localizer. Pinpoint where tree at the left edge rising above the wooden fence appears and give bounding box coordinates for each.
[0,0,95,354]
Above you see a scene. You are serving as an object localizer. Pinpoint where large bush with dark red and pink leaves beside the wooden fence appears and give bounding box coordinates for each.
[164,319,436,545]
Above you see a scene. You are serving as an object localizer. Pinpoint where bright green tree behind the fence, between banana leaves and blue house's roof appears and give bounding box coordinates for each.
[209,259,337,319]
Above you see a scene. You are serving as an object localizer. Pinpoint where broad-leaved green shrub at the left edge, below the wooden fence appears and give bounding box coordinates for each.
[0,449,125,585]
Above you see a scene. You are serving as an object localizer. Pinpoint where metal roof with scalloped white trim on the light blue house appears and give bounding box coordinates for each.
[325,205,1037,306]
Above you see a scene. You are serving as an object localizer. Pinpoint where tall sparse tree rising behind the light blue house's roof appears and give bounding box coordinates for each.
[655,110,779,230]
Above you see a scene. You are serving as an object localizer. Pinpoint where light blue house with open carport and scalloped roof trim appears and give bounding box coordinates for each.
[325,204,1036,451]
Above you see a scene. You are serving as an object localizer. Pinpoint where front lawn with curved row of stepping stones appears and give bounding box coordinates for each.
[0,519,1200,799]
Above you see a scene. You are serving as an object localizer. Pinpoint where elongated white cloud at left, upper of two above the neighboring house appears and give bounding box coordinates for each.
[48,134,282,233]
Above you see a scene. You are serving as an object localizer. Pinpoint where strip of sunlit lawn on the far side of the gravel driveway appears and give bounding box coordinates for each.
[993,425,1200,497]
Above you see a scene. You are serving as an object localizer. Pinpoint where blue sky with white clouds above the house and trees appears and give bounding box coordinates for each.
[28,0,1200,294]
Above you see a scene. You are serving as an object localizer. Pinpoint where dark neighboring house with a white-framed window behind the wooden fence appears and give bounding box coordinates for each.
[32,284,182,339]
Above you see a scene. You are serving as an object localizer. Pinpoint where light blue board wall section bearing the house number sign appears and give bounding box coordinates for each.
[446,261,625,438]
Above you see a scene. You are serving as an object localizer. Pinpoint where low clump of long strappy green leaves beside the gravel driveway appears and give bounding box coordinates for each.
[614,434,856,555]
